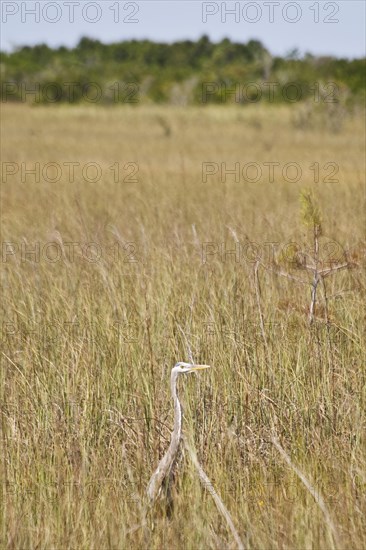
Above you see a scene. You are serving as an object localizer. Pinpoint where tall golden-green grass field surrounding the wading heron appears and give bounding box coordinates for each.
[0,105,366,550]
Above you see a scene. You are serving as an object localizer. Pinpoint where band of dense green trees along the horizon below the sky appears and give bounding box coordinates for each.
[1,36,365,104]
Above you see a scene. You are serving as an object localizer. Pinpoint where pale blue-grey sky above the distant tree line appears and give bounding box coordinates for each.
[0,0,366,58]
